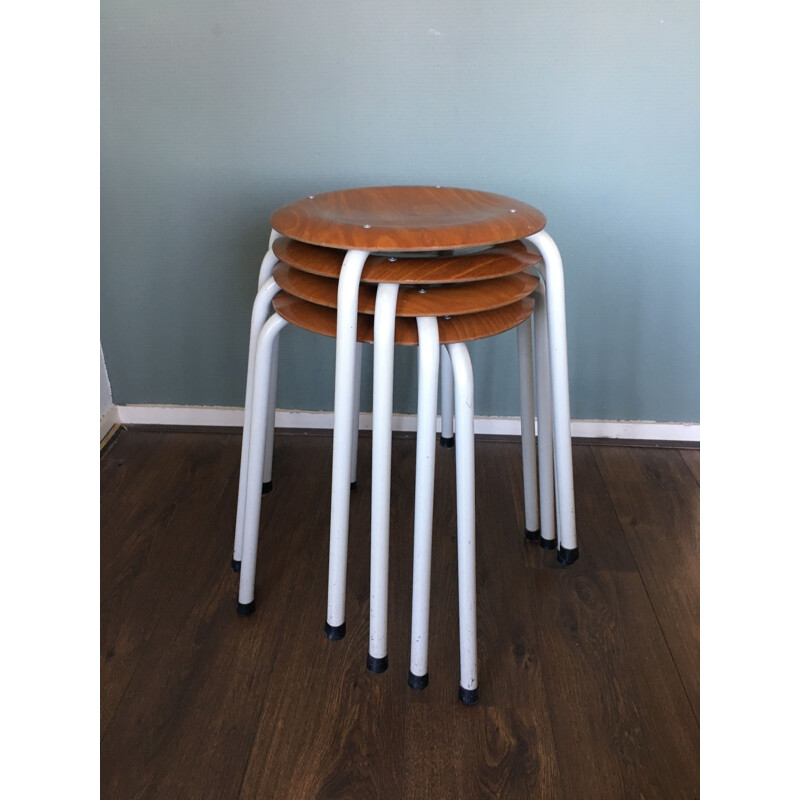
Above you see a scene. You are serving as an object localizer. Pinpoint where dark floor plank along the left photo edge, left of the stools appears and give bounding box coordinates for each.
[100,431,238,735]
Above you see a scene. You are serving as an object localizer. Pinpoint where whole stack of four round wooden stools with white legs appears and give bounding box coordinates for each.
[228,186,578,704]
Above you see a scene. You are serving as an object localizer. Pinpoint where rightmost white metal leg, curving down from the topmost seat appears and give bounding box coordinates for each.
[528,231,578,565]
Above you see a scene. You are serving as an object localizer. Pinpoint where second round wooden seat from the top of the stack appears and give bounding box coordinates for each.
[272,237,542,284]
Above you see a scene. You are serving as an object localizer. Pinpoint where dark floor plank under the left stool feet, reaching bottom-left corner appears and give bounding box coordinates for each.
[101,435,330,798]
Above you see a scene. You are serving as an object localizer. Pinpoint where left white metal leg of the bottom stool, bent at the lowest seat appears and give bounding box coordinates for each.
[239,314,287,613]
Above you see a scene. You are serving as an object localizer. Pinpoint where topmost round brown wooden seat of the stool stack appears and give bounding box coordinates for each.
[271,186,546,252]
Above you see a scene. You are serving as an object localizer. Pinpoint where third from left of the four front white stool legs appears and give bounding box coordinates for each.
[408,317,440,689]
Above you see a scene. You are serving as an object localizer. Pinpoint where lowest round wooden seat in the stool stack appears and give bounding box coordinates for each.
[272,291,533,345]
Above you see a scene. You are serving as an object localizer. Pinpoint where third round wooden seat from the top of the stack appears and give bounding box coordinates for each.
[272,262,539,317]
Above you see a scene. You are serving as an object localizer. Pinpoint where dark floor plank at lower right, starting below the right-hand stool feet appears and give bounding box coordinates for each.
[532,569,700,800]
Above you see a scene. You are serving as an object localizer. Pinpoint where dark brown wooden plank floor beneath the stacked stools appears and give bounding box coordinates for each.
[101,430,700,800]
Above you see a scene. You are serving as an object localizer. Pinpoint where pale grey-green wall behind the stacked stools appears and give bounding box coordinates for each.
[101,0,699,422]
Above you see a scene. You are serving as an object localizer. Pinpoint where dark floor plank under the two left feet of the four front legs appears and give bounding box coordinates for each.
[240,437,414,800]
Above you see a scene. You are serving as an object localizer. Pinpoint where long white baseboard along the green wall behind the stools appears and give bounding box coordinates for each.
[114,405,700,442]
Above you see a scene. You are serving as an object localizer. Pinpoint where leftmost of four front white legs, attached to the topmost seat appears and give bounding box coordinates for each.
[325,250,369,639]
